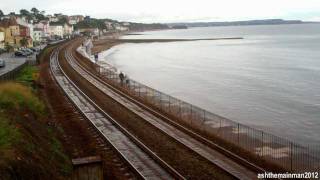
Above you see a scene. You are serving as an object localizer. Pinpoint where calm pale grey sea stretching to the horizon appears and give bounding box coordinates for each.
[100,24,320,144]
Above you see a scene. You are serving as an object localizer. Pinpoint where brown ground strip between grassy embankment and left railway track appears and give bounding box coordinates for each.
[40,47,141,179]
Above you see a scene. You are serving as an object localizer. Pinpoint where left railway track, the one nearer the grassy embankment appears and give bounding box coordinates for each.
[50,45,184,179]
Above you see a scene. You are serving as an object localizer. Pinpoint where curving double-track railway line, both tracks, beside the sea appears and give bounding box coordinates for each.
[50,40,264,179]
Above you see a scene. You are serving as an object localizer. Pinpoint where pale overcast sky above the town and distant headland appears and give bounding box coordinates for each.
[0,0,320,23]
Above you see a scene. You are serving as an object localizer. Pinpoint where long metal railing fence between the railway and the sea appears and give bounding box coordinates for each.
[76,49,320,172]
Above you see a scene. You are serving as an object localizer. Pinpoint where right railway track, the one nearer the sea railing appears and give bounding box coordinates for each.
[64,38,263,179]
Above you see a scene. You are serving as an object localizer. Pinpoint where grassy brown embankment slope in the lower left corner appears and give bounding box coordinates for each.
[0,81,71,179]
